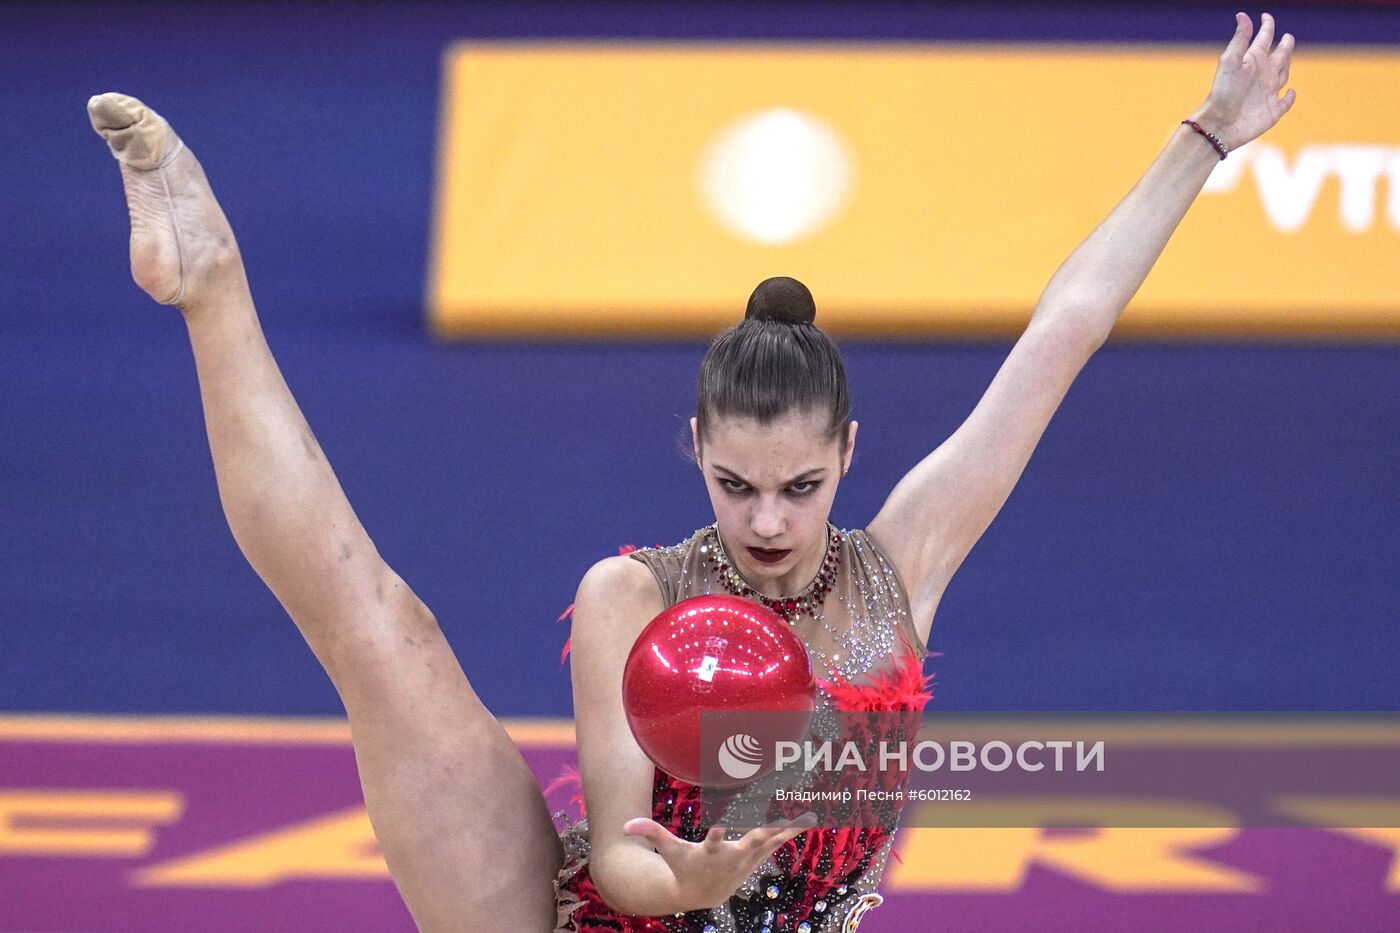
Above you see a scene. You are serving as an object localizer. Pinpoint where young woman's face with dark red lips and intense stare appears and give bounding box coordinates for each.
[690,412,855,587]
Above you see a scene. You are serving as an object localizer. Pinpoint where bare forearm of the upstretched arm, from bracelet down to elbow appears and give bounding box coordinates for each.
[1032,118,1219,347]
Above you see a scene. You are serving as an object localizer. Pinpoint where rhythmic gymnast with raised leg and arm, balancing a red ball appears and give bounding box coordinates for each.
[88,14,1294,933]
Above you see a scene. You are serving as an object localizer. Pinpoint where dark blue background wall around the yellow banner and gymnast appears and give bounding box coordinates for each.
[0,4,1400,714]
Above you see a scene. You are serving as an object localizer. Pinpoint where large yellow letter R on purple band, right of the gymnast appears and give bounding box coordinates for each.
[889,799,1263,892]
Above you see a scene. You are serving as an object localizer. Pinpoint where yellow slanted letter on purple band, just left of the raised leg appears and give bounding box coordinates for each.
[132,807,389,888]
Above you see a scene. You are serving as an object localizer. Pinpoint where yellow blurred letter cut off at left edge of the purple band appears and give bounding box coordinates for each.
[0,789,185,859]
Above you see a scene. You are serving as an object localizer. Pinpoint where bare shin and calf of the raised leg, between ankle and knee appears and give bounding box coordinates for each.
[185,280,402,638]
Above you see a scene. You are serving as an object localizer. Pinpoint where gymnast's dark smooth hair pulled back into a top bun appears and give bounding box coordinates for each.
[696,277,851,440]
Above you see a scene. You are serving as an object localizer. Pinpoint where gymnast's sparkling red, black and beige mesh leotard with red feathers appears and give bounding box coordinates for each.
[550,531,931,933]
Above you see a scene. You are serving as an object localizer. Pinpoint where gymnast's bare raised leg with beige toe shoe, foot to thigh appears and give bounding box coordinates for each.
[88,94,563,933]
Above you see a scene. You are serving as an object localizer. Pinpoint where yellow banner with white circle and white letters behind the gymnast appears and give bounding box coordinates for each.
[428,43,1400,336]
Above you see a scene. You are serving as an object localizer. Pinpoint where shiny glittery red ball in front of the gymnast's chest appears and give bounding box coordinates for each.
[622,595,816,787]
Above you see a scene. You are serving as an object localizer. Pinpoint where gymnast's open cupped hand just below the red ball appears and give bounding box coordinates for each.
[623,813,816,911]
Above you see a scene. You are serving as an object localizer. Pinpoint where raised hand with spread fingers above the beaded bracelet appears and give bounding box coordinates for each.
[1196,13,1296,148]
